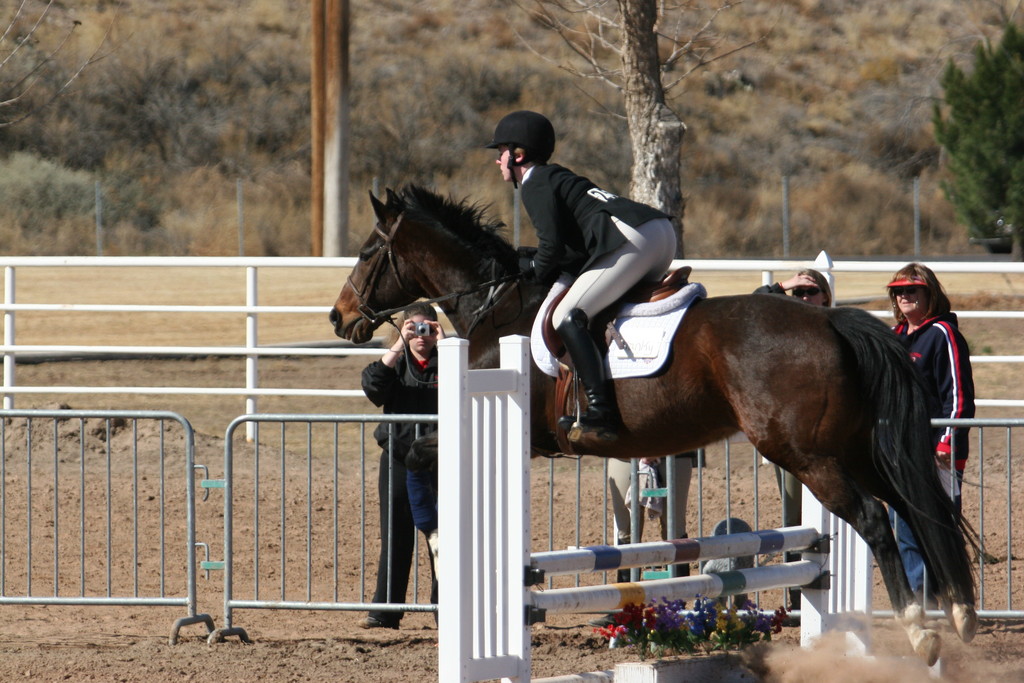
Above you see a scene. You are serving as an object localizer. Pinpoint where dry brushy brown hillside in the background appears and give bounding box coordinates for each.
[0,0,1016,258]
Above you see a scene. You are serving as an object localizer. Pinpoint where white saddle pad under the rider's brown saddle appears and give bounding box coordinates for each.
[529,276,708,379]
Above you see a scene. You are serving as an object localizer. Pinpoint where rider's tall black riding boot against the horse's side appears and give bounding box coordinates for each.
[558,308,622,441]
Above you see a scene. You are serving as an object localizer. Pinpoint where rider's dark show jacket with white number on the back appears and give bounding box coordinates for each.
[522,164,669,283]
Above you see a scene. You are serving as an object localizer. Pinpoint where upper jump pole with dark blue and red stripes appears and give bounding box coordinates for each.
[530,526,821,583]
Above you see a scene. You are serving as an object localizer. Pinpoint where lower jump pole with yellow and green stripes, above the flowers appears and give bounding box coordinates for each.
[530,560,821,614]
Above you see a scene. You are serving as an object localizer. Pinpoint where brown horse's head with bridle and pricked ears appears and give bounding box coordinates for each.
[330,189,424,344]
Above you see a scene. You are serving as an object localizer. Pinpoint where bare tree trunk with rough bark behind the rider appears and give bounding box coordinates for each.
[618,0,686,258]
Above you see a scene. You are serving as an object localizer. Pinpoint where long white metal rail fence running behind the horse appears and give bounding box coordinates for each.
[0,252,1024,413]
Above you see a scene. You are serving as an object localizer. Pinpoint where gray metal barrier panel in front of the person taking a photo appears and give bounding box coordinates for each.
[209,414,437,642]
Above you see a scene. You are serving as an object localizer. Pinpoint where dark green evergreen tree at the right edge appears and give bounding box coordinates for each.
[933,24,1024,259]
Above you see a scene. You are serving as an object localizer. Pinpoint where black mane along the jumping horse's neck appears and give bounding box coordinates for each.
[398,184,518,271]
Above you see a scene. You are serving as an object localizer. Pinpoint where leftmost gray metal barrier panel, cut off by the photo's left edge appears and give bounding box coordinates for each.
[0,410,213,644]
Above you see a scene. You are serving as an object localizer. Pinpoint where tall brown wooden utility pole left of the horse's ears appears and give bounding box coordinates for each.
[310,0,349,256]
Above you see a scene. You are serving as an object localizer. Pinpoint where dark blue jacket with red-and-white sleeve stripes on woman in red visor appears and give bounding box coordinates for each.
[893,313,975,471]
